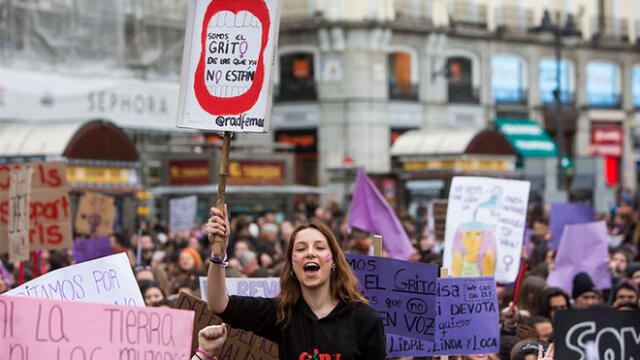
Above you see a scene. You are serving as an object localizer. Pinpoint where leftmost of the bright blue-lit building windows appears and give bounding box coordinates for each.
[491,55,527,104]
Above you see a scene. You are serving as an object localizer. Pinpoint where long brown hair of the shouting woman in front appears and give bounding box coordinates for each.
[277,222,368,327]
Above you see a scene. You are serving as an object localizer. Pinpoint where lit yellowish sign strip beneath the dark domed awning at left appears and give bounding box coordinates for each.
[67,165,138,185]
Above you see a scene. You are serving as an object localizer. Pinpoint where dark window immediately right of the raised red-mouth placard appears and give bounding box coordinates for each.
[275,53,318,101]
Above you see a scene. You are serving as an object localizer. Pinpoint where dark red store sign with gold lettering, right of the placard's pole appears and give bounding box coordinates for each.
[227,160,285,185]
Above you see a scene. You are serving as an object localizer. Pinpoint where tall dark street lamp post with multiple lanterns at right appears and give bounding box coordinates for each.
[533,10,581,189]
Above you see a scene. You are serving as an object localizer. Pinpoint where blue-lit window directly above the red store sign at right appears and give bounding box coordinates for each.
[586,61,621,108]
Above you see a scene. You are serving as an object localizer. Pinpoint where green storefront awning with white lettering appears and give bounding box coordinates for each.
[496,119,558,158]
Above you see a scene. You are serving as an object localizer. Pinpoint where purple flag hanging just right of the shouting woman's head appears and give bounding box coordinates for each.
[347,169,415,260]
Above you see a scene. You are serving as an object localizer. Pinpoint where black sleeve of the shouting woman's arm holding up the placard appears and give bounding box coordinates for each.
[220,295,280,343]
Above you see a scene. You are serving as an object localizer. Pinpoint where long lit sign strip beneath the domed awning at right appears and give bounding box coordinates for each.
[402,159,514,171]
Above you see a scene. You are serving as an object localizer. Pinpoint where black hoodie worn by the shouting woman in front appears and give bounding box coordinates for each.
[220,296,386,360]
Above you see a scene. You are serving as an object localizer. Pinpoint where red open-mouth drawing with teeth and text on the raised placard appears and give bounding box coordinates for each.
[194,0,271,115]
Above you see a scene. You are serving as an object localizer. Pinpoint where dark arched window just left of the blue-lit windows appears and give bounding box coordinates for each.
[447,56,479,104]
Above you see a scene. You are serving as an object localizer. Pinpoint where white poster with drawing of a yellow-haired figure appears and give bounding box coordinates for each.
[443,177,530,283]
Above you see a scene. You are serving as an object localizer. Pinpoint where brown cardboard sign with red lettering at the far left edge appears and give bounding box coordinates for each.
[0,162,72,253]
